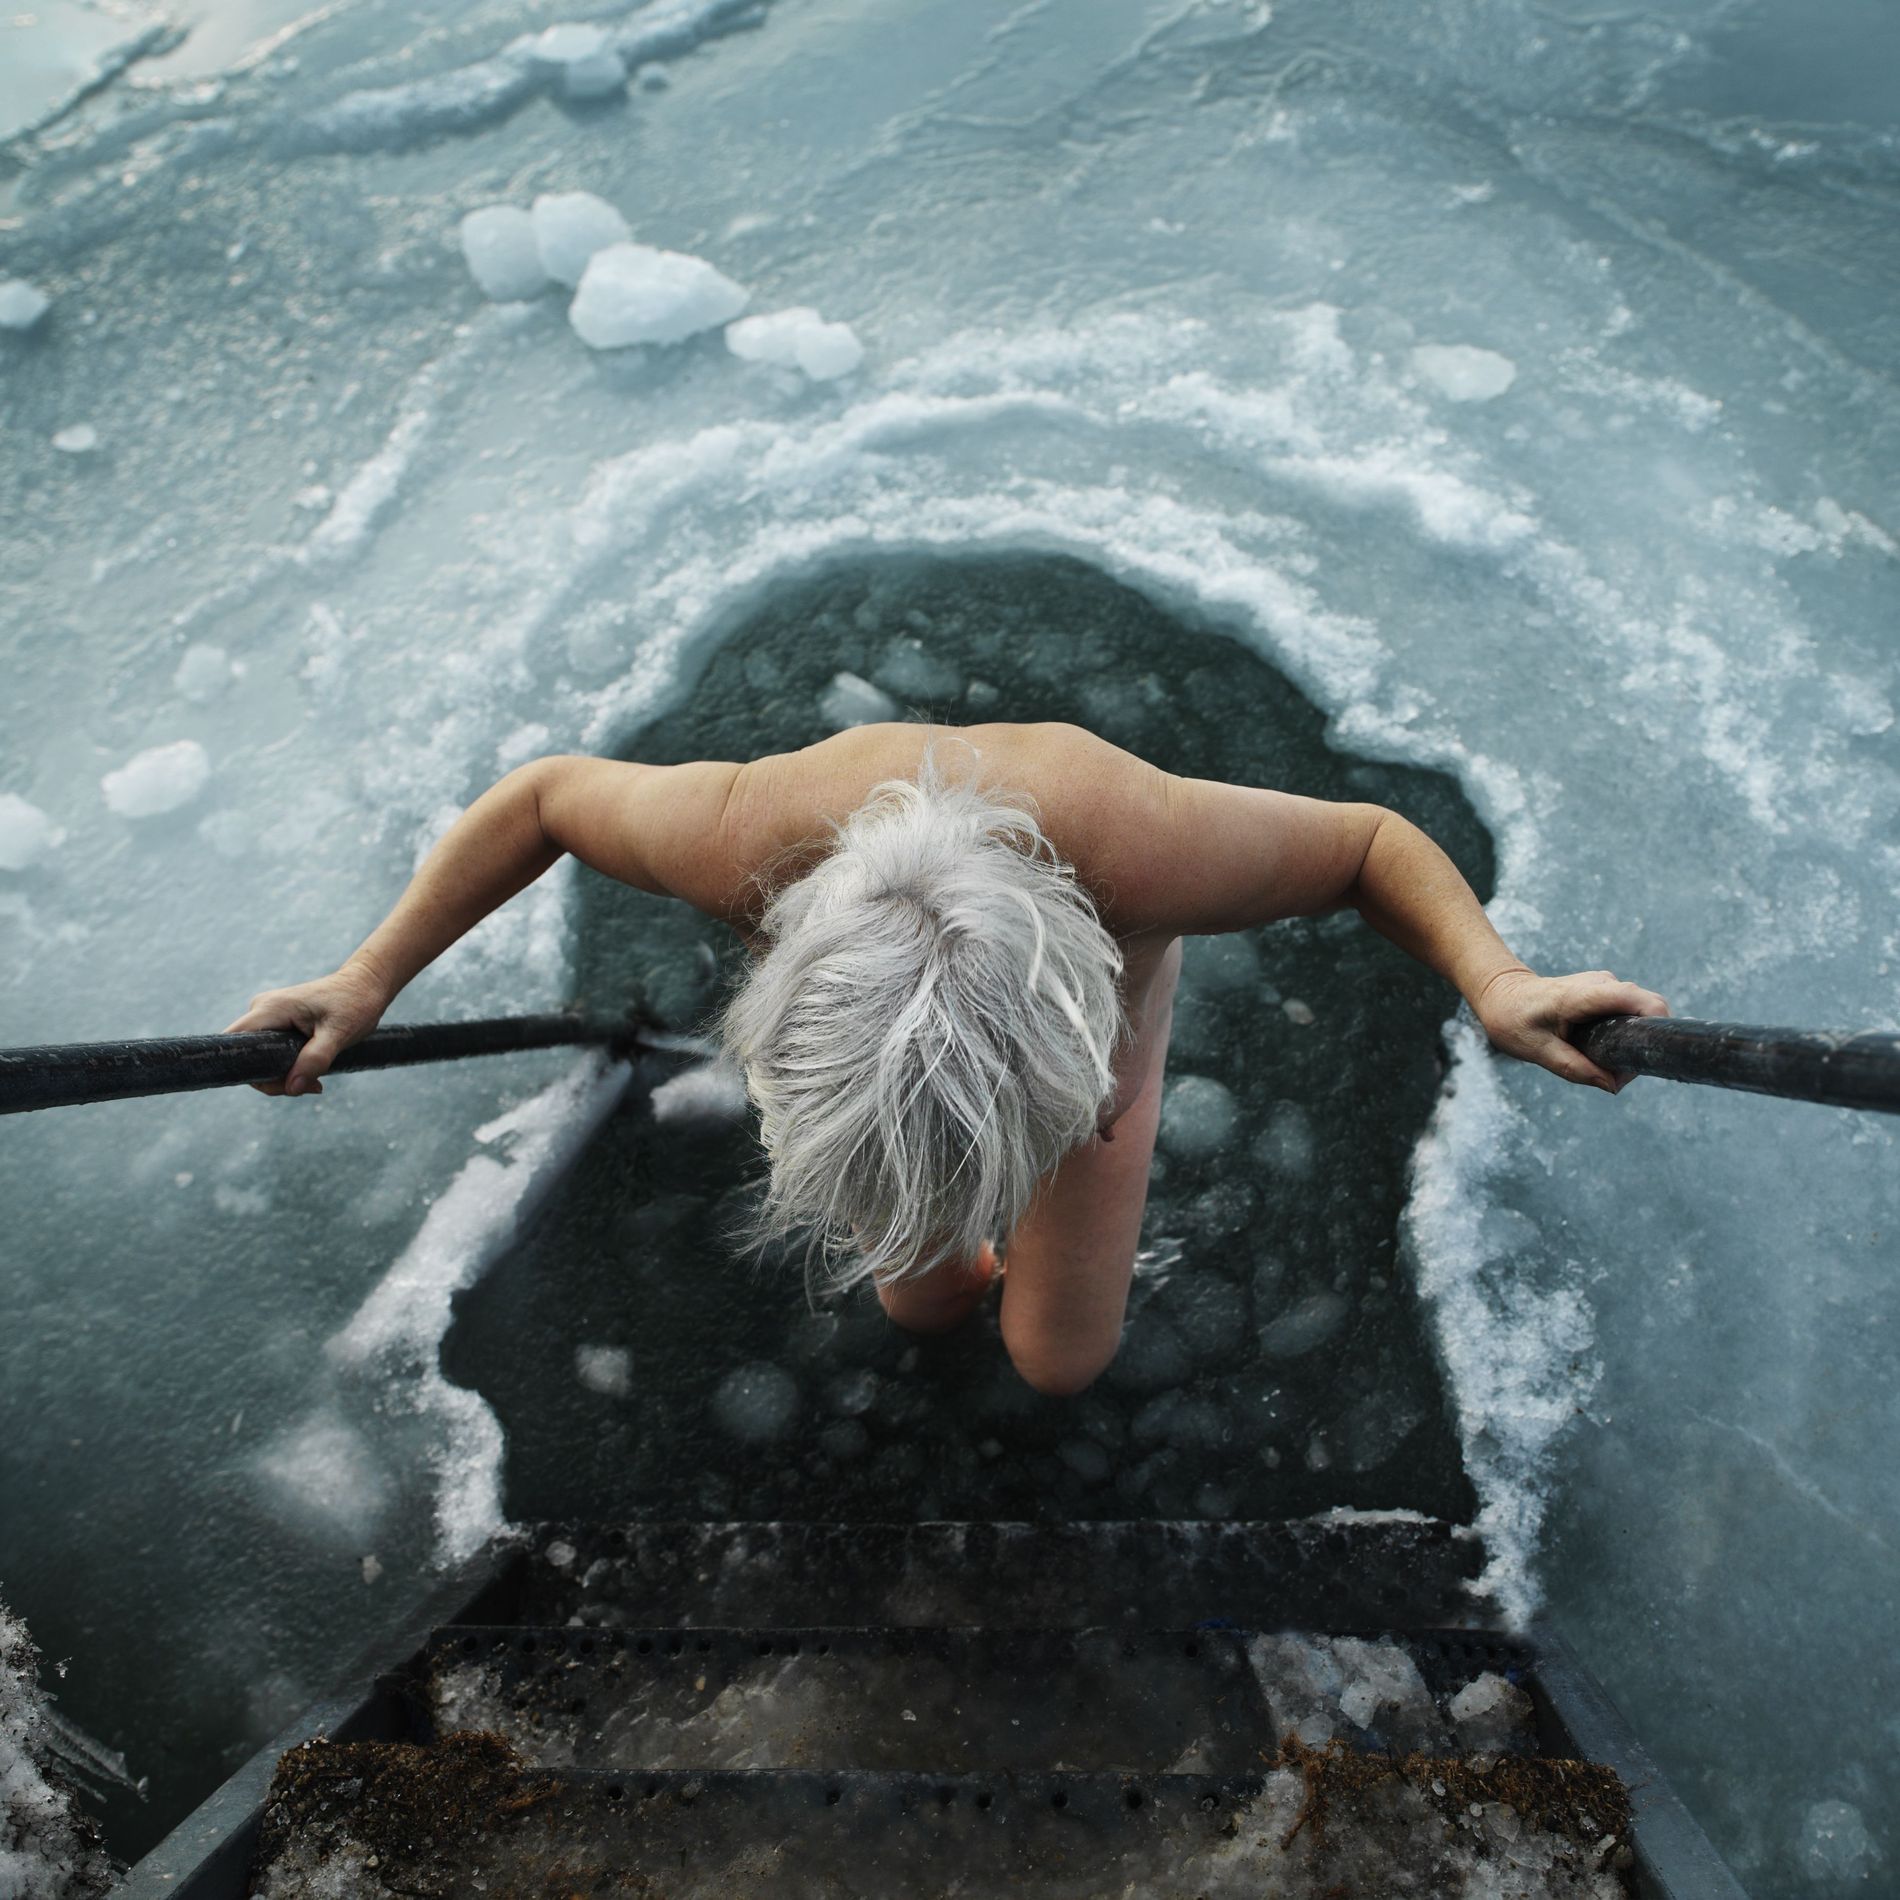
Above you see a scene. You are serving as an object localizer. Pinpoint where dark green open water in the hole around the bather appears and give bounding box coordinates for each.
[443,559,1492,1520]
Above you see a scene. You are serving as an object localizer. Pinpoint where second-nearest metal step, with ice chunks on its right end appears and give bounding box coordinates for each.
[420,1626,1549,1773]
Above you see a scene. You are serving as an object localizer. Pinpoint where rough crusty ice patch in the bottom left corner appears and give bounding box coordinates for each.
[0,1604,114,1900]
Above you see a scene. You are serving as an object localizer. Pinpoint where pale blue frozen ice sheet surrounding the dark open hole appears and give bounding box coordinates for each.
[0,0,1900,1894]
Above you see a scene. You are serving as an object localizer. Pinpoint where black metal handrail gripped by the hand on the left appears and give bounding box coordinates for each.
[0,1015,661,1115]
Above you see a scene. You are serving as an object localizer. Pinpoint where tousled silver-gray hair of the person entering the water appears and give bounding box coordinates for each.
[720,751,1125,1284]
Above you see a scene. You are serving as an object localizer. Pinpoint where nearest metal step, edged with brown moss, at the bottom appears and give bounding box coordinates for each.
[253,1735,1634,1900]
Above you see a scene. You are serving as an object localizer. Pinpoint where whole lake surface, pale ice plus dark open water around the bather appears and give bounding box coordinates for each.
[0,0,1900,1900]
